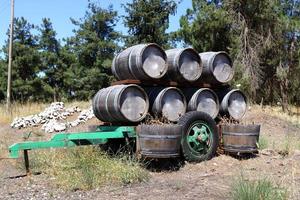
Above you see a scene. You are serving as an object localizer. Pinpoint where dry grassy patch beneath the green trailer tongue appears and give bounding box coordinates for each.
[24,147,149,190]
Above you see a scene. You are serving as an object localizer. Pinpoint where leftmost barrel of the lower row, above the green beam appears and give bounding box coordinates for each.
[93,84,149,122]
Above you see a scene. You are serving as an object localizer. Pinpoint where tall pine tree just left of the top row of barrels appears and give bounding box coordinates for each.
[66,3,120,99]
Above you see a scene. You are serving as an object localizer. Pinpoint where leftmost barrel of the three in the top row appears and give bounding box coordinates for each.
[112,43,168,80]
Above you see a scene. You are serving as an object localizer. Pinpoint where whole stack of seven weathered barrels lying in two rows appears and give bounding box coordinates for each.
[93,43,247,123]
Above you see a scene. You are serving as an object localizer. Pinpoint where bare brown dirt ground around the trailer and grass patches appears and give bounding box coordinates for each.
[0,107,300,199]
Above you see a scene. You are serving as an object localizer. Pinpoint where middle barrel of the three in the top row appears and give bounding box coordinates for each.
[166,48,202,82]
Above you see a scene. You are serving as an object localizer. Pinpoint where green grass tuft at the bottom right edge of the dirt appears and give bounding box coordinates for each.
[231,177,288,200]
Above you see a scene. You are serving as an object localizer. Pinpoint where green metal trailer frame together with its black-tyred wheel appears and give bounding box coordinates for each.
[9,111,223,174]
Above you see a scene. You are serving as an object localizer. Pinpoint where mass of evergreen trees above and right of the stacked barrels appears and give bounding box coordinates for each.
[176,0,300,110]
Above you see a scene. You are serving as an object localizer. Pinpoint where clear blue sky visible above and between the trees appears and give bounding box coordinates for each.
[0,0,192,47]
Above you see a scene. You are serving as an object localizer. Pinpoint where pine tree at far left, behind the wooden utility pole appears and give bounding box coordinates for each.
[2,17,42,101]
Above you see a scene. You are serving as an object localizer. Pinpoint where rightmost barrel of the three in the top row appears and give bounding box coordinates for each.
[199,51,234,84]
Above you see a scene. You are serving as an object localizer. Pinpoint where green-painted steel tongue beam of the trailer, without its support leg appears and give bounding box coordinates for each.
[9,126,136,158]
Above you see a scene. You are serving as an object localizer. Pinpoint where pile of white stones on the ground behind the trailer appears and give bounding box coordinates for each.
[11,102,94,133]
